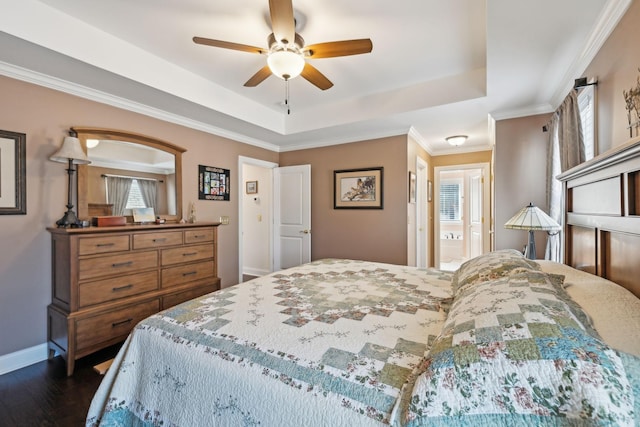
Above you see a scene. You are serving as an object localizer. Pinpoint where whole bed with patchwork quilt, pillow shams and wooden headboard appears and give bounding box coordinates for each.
[87,139,640,427]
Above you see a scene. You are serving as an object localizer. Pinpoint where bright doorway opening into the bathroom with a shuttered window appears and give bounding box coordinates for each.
[434,164,490,271]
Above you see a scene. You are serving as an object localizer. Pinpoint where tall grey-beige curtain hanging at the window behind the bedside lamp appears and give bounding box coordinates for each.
[545,90,585,262]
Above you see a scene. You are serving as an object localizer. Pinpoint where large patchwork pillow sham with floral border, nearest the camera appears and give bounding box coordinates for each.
[405,270,640,426]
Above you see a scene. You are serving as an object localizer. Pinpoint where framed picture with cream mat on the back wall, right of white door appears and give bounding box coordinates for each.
[333,167,383,209]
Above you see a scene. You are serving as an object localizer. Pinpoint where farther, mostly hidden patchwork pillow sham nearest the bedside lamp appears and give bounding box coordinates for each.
[451,249,540,295]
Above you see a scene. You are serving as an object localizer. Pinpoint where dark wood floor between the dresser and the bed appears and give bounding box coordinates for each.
[0,345,119,427]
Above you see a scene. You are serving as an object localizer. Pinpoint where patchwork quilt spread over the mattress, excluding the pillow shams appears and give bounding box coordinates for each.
[87,259,451,426]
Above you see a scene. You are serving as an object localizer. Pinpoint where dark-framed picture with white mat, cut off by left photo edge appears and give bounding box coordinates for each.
[0,130,27,215]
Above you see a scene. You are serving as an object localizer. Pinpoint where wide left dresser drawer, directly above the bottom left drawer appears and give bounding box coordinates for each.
[79,270,158,307]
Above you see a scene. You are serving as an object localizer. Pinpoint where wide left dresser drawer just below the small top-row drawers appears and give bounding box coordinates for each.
[78,251,158,281]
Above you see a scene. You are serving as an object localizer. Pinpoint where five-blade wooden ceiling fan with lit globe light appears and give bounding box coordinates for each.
[193,0,373,90]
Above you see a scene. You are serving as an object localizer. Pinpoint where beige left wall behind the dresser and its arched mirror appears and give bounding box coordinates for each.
[0,77,278,356]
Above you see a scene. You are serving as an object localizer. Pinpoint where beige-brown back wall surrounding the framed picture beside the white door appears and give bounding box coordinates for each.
[280,135,409,264]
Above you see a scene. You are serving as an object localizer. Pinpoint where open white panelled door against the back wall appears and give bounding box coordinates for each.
[273,165,311,271]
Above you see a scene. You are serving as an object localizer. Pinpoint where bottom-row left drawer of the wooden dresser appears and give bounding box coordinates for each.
[76,299,160,352]
